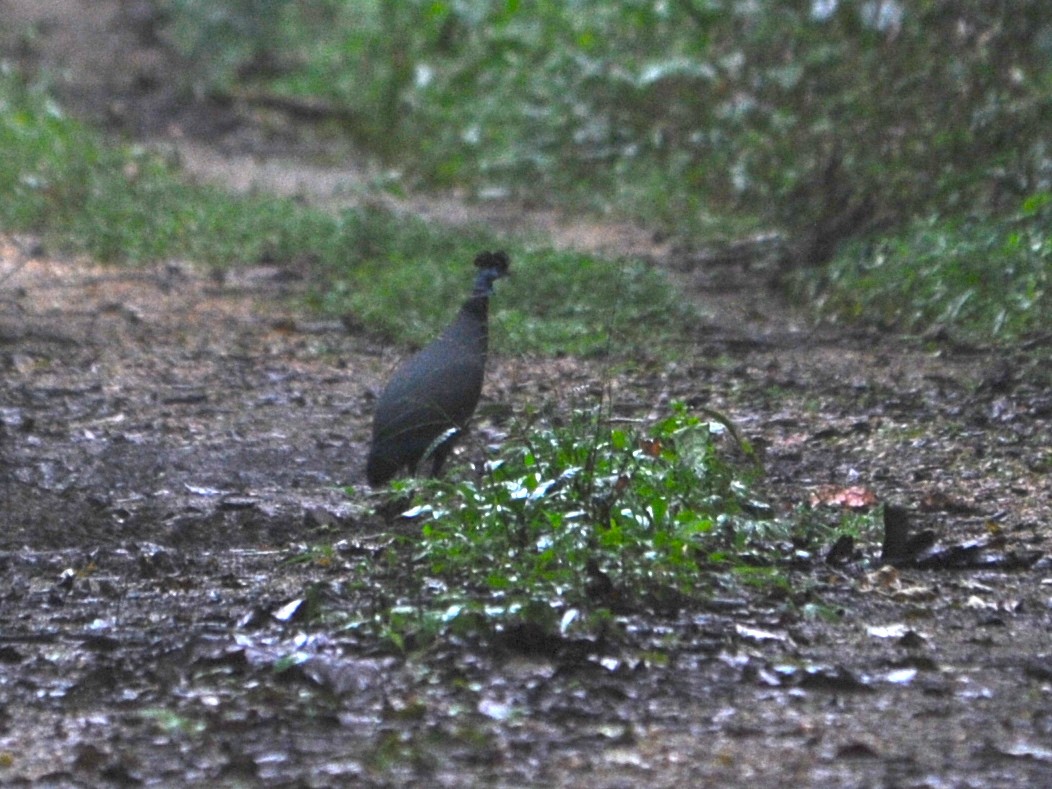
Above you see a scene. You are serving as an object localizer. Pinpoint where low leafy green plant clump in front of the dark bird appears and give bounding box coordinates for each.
[346,404,881,652]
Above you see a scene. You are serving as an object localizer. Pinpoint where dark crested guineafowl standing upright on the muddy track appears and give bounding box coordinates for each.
[365,251,508,486]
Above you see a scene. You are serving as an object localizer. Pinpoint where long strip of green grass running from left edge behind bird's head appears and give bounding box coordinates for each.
[0,72,694,356]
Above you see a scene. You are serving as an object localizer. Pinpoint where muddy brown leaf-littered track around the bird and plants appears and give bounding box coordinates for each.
[0,0,1052,787]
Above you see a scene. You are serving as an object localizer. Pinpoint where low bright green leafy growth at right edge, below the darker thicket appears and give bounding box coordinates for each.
[796,200,1052,340]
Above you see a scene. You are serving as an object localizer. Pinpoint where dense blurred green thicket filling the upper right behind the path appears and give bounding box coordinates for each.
[157,0,1052,339]
